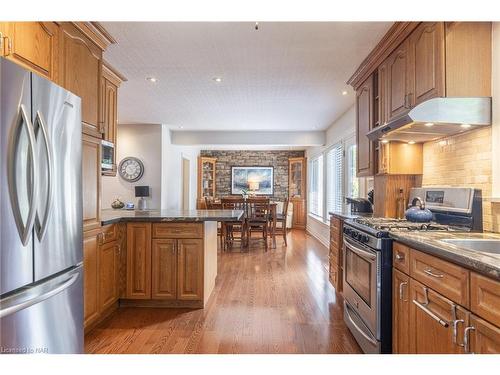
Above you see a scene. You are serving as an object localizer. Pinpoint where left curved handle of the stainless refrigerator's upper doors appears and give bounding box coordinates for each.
[7,104,38,246]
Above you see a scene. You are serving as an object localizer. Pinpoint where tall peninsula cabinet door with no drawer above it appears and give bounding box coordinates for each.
[126,223,151,299]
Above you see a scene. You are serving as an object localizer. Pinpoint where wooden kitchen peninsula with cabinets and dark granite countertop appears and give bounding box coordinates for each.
[83,210,243,331]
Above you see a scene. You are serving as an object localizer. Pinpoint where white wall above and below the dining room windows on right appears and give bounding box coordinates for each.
[306,105,356,247]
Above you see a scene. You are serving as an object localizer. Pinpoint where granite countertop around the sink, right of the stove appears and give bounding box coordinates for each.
[390,232,500,280]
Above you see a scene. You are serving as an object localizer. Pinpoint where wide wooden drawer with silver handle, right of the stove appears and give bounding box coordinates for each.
[410,250,469,307]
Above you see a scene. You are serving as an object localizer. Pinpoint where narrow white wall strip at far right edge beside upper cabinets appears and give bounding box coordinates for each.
[491,22,500,198]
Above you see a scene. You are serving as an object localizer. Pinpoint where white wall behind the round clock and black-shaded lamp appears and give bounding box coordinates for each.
[101,124,161,209]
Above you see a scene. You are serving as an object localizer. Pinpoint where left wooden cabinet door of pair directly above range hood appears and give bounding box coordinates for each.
[386,39,412,121]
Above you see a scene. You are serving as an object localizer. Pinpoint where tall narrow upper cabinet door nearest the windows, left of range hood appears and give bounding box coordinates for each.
[356,76,373,177]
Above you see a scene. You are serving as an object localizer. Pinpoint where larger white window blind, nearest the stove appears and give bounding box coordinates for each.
[326,143,344,212]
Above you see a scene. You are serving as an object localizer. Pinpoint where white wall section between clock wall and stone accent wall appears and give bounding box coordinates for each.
[161,125,200,210]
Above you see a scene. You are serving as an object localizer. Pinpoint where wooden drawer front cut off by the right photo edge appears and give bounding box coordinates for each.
[470,272,500,327]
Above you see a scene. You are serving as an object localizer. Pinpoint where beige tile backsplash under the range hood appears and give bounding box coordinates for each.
[422,127,500,232]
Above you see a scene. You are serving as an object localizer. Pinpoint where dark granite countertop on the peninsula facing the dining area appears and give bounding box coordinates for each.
[101,209,243,225]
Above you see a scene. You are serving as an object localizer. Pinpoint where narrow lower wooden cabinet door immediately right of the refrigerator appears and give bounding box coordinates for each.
[83,231,99,327]
